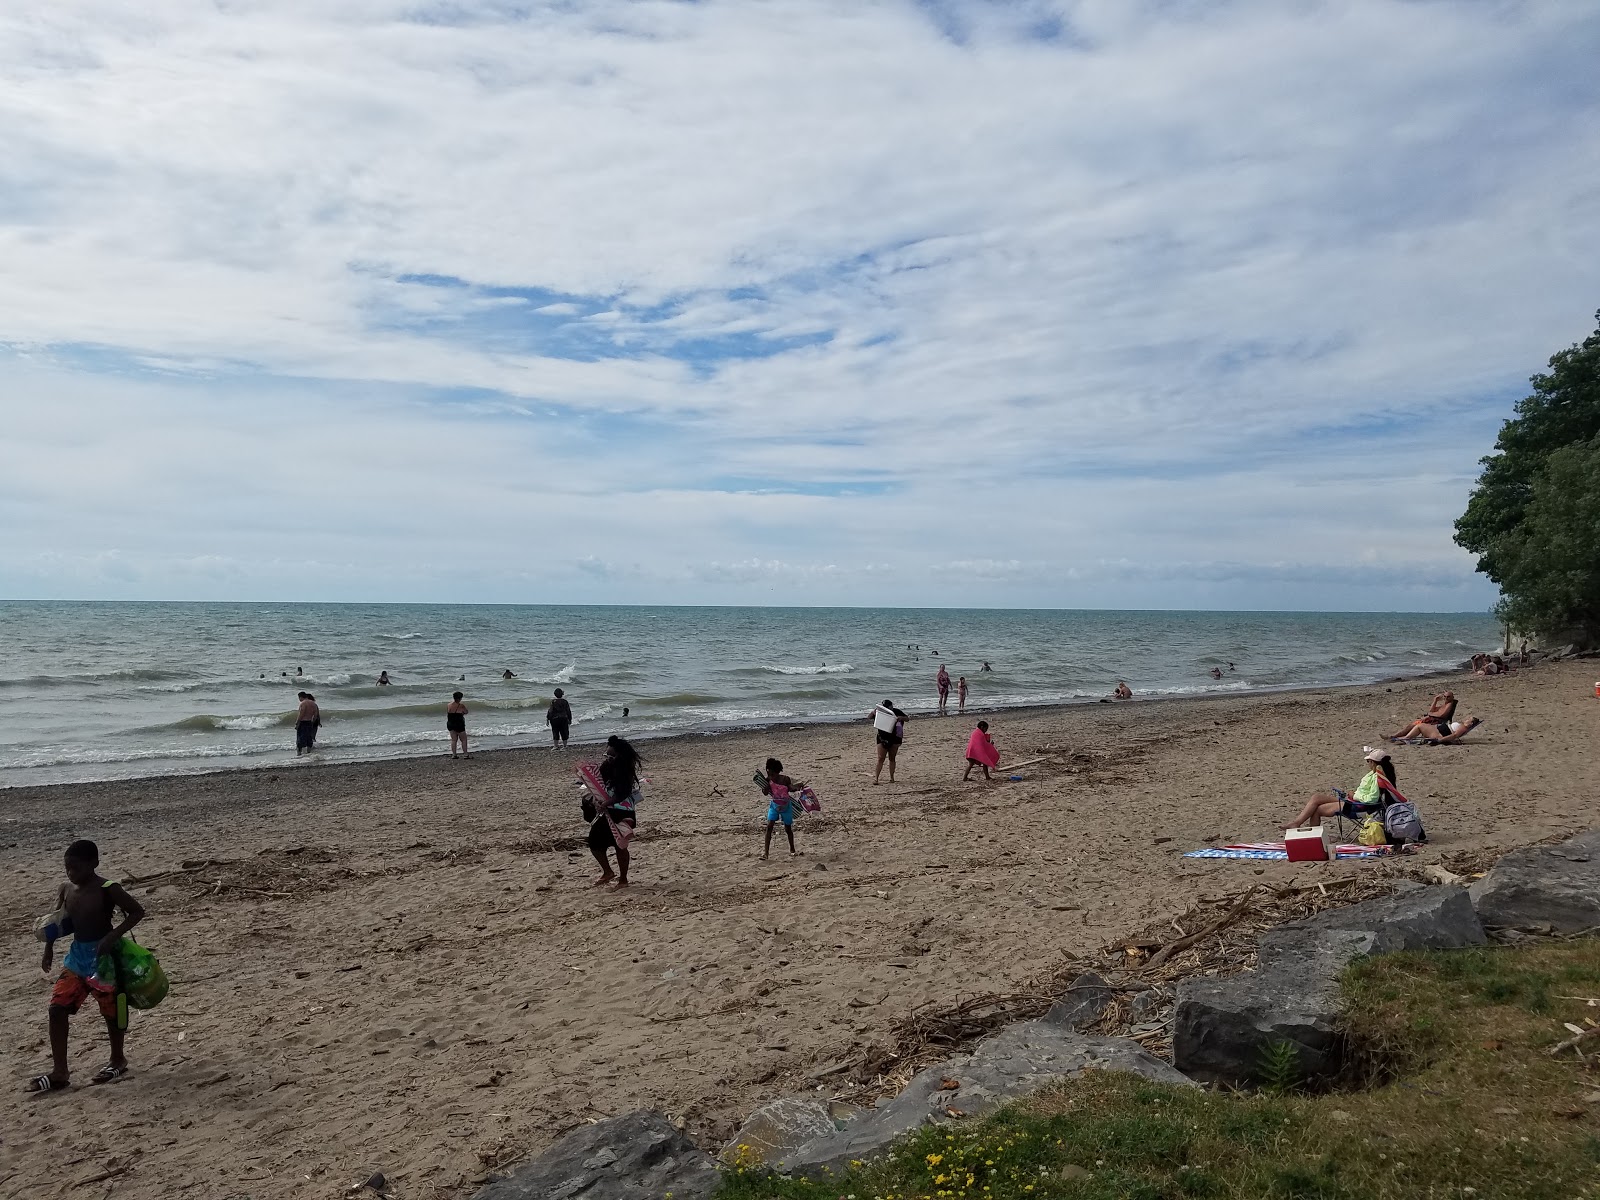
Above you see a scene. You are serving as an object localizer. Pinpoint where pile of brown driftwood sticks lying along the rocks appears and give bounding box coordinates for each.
[830,862,1411,1099]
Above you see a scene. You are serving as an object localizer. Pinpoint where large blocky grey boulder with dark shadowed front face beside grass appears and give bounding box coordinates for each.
[1173,888,1485,1086]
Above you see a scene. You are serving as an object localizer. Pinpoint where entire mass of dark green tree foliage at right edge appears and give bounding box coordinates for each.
[1456,312,1600,640]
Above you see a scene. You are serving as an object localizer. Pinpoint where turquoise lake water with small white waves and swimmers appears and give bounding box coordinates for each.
[0,602,1498,786]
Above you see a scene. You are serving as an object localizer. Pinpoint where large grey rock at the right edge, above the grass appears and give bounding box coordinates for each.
[1472,829,1600,933]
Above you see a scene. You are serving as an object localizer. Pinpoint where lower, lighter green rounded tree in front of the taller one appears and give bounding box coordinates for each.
[1493,437,1600,643]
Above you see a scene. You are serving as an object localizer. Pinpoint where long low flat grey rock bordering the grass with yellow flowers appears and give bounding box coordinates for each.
[771,1019,1192,1176]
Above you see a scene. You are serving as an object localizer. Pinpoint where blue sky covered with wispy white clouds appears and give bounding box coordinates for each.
[0,0,1600,611]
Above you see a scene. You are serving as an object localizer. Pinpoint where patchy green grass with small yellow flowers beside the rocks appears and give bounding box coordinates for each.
[717,941,1600,1200]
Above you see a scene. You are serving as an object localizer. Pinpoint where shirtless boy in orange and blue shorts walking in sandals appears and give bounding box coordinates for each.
[27,842,144,1091]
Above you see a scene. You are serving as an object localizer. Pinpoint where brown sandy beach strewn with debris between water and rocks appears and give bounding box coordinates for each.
[0,662,1600,1200]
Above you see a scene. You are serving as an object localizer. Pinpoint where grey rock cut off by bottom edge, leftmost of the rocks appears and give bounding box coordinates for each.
[475,1110,720,1200]
